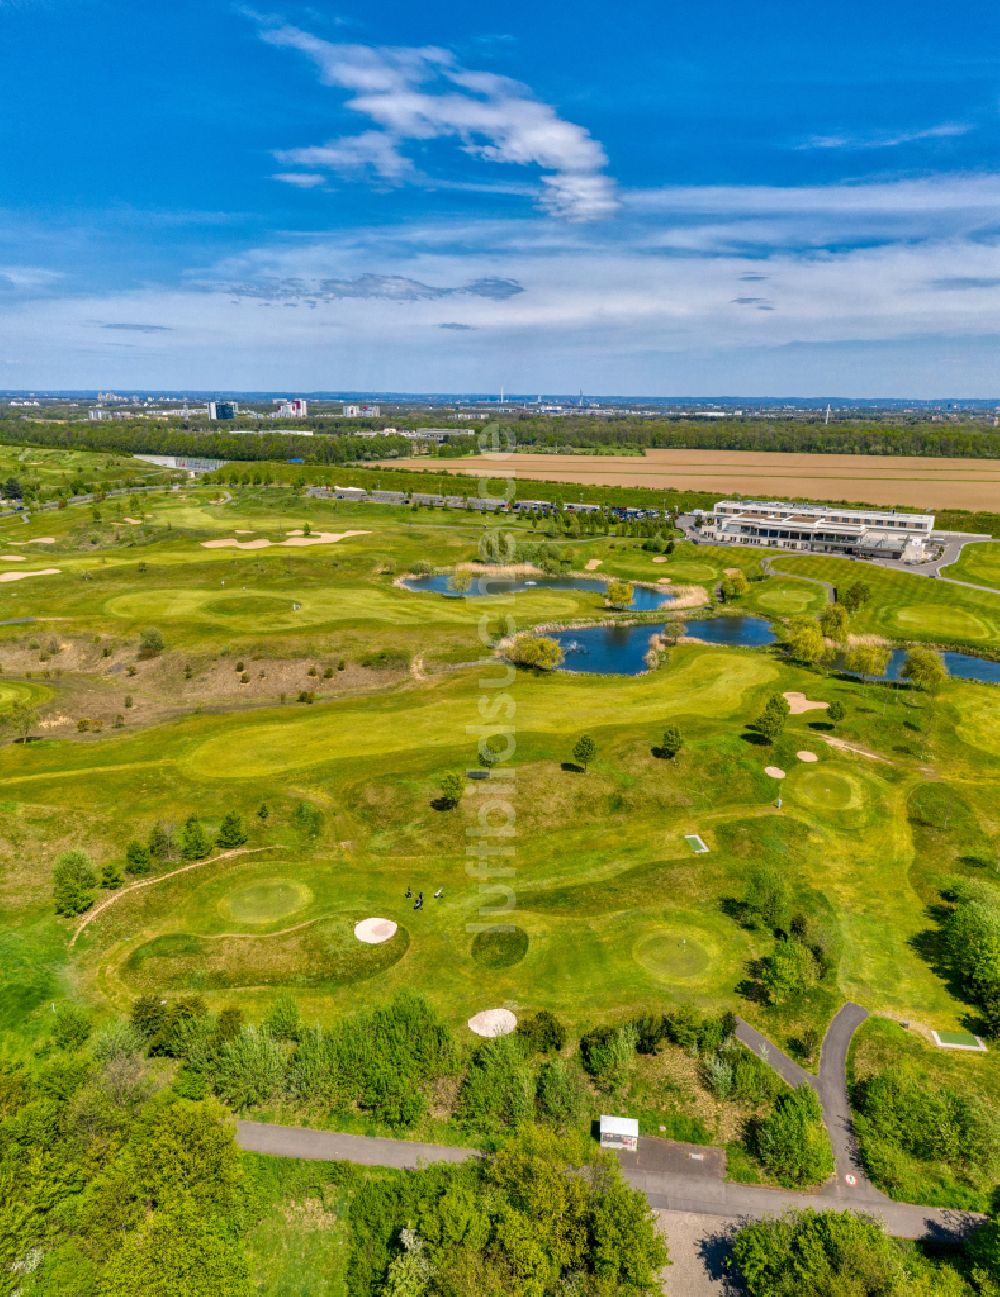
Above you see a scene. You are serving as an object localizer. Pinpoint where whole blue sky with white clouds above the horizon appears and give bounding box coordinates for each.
[0,0,1000,397]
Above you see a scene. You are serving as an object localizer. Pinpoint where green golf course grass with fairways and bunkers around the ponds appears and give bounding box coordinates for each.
[0,484,1000,1234]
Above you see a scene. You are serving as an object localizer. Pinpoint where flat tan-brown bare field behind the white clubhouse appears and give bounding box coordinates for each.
[393,450,1000,510]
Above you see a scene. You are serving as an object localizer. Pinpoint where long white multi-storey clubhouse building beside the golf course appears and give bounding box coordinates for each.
[700,499,934,563]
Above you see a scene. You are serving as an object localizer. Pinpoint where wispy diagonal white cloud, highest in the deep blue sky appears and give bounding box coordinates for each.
[261,26,619,220]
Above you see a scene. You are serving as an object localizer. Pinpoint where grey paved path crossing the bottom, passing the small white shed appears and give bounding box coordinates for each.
[236,1122,982,1240]
